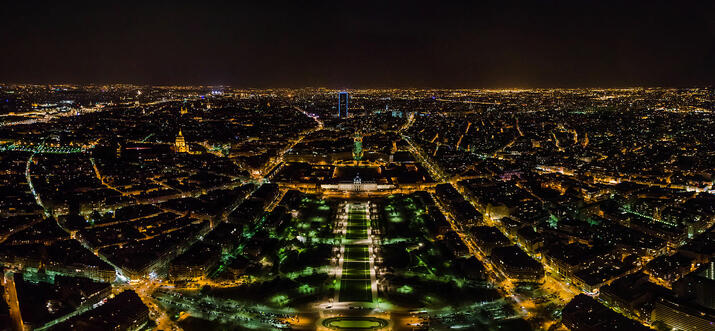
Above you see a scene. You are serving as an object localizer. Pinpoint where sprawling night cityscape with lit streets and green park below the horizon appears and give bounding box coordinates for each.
[0,84,715,330]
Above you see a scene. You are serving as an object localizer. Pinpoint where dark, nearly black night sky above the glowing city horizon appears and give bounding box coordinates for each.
[0,0,715,88]
